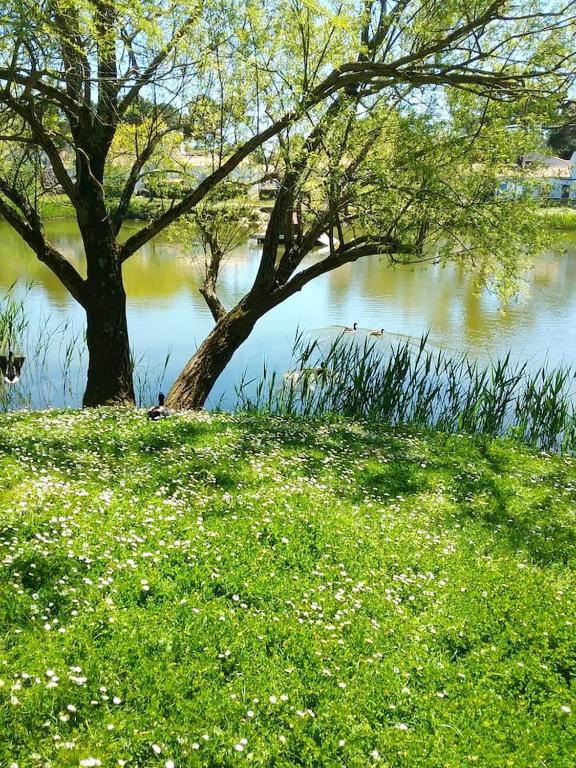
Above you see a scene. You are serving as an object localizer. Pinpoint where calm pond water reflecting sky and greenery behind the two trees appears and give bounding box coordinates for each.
[0,220,576,407]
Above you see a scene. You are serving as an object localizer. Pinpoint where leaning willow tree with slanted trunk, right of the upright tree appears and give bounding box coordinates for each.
[168,0,575,408]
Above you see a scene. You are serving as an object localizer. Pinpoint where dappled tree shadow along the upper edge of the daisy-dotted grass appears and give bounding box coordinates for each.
[0,412,576,565]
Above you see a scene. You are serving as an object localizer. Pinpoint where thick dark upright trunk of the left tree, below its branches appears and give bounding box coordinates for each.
[83,250,134,407]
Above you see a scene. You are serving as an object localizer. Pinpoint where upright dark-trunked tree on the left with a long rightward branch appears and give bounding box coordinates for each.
[0,0,382,405]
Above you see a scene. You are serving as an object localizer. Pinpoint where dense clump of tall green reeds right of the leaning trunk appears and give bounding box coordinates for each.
[237,334,576,453]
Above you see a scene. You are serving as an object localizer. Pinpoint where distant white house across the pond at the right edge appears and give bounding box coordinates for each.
[498,152,576,205]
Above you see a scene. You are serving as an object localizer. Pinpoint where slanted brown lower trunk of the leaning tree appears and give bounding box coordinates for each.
[166,307,260,410]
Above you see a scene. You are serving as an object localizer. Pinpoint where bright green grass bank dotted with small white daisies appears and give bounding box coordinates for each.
[0,409,576,768]
